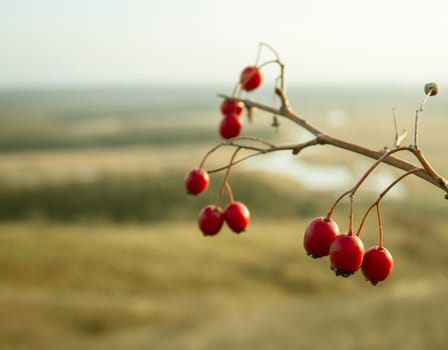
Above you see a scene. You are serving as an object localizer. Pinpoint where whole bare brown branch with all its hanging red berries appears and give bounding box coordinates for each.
[185,43,448,285]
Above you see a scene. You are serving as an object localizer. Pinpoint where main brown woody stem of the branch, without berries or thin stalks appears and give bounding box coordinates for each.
[215,88,448,199]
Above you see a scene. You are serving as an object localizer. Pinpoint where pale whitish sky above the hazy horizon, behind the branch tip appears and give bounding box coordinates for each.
[0,0,448,88]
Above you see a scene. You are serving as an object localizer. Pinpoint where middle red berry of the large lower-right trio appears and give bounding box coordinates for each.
[330,233,364,277]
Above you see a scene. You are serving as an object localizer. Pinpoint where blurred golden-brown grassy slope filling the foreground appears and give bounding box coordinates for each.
[0,219,448,350]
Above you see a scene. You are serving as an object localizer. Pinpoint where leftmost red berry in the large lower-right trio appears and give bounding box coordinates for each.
[303,216,339,258]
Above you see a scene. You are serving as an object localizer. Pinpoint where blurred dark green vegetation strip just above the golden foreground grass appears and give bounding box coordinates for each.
[0,172,334,222]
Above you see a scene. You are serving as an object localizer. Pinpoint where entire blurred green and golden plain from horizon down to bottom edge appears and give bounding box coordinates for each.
[0,86,448,350]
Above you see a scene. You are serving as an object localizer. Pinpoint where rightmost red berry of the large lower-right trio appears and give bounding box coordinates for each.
[361,246,394,285]
